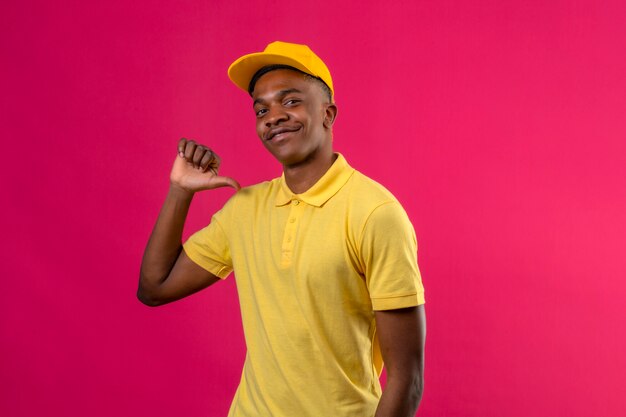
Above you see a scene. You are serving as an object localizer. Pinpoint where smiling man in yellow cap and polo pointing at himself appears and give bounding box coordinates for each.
[138,42,425,417]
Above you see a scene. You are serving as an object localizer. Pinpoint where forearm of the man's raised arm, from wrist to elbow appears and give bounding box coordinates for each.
[139,185,193,292]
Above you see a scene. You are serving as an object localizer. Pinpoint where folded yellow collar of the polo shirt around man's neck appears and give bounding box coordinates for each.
[276,153,354,207]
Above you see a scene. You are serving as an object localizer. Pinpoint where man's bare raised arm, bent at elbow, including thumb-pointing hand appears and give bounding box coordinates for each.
[137,139,239,306]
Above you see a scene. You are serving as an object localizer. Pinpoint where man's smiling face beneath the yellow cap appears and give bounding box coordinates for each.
[252,69,334,166]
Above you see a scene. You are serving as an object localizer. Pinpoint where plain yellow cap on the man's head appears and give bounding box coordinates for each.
[228,41,335,95]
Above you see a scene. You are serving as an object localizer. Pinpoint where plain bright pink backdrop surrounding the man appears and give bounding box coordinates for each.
[0,0,626,417]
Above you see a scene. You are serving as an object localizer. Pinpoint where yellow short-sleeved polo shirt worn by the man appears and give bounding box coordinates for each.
[184,155,424,417]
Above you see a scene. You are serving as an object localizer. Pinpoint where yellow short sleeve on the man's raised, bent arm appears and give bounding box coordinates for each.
[183,214,233,279]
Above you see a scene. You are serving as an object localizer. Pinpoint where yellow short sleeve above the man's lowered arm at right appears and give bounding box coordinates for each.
[360,201,424,310]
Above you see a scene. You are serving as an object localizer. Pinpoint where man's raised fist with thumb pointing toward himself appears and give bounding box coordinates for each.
[170,138,241,193]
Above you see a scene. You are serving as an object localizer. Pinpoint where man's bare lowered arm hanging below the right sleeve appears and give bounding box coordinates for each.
[376,305,426,417]
